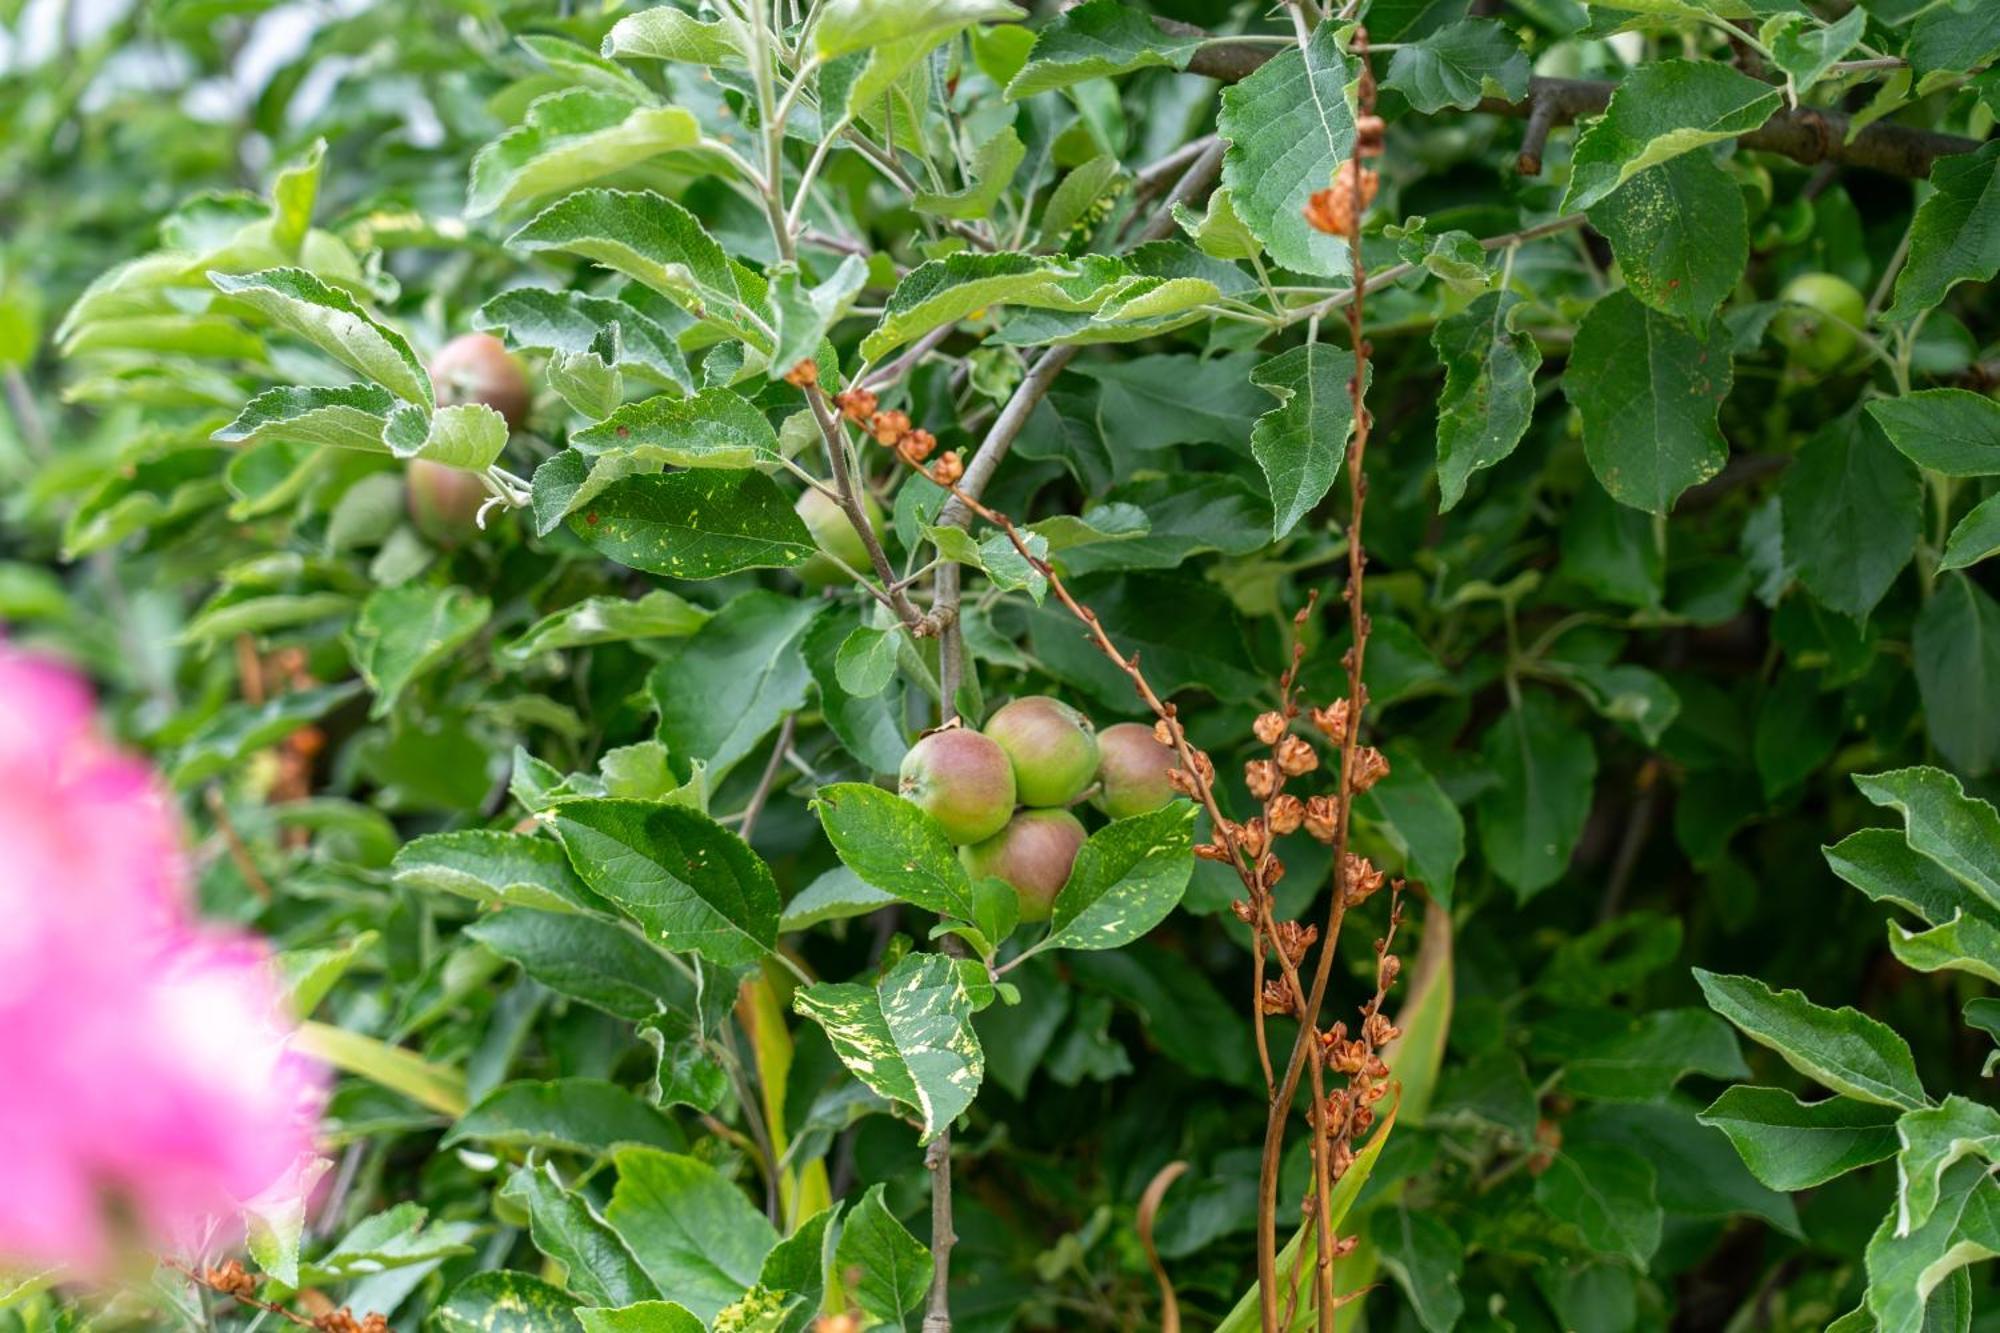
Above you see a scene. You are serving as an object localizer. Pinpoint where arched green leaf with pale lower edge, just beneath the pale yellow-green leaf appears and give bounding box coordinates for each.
[508,190,750,336]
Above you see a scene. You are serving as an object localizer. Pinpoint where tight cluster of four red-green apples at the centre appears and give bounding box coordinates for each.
[900,695,1180,921]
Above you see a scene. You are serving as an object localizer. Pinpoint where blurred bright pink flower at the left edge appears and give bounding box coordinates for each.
[0,642,320,1271]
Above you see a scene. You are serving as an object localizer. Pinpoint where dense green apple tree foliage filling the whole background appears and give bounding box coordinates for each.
[0,0,2000,1333]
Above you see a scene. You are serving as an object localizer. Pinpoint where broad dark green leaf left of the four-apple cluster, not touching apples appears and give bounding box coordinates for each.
[554,801,778,967]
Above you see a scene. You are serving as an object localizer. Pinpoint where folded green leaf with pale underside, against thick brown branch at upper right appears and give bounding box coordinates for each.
[1562,60,1784,212]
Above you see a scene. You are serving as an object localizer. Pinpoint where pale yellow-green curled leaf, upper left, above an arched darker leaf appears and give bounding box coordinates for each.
[466,88,702,218]
